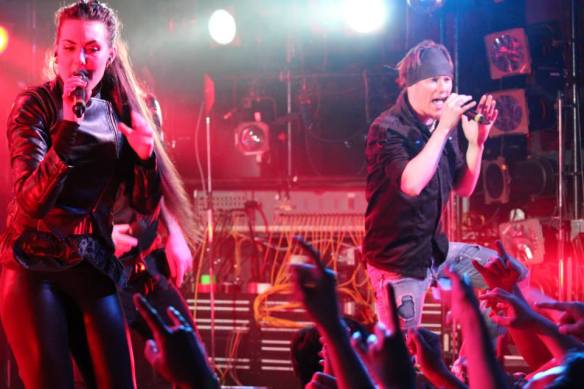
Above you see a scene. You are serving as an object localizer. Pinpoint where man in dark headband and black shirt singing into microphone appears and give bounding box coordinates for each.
[363,40,498,328]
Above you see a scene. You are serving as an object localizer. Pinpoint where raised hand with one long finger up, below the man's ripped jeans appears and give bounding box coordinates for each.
[351,282,416,388]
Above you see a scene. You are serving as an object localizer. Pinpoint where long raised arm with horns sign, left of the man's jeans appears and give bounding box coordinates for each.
[290,237,374,389]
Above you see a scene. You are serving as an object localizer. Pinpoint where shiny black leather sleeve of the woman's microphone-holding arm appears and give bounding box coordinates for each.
[7,91,70,218]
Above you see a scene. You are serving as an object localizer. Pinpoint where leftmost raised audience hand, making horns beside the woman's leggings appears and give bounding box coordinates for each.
[134,294,219,389]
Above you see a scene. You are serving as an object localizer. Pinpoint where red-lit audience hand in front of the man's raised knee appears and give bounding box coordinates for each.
[472,241,521,292]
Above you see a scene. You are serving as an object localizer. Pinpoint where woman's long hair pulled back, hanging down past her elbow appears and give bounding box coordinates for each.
[46,0,197,249]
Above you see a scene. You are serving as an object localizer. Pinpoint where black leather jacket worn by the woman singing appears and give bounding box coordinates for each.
[2,80,161,278]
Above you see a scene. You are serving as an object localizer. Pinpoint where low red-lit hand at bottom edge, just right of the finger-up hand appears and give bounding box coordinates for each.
[407,327,466,389]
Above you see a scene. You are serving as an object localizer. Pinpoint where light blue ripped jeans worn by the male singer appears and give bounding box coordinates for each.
[367,242,527,330]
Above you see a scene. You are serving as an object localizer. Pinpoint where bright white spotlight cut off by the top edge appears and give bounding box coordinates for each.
[343,0,387,34]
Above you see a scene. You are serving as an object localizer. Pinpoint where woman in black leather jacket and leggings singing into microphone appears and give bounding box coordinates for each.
[0,0,161,389]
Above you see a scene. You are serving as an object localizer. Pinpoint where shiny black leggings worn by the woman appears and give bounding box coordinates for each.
[0,262,135,389]
